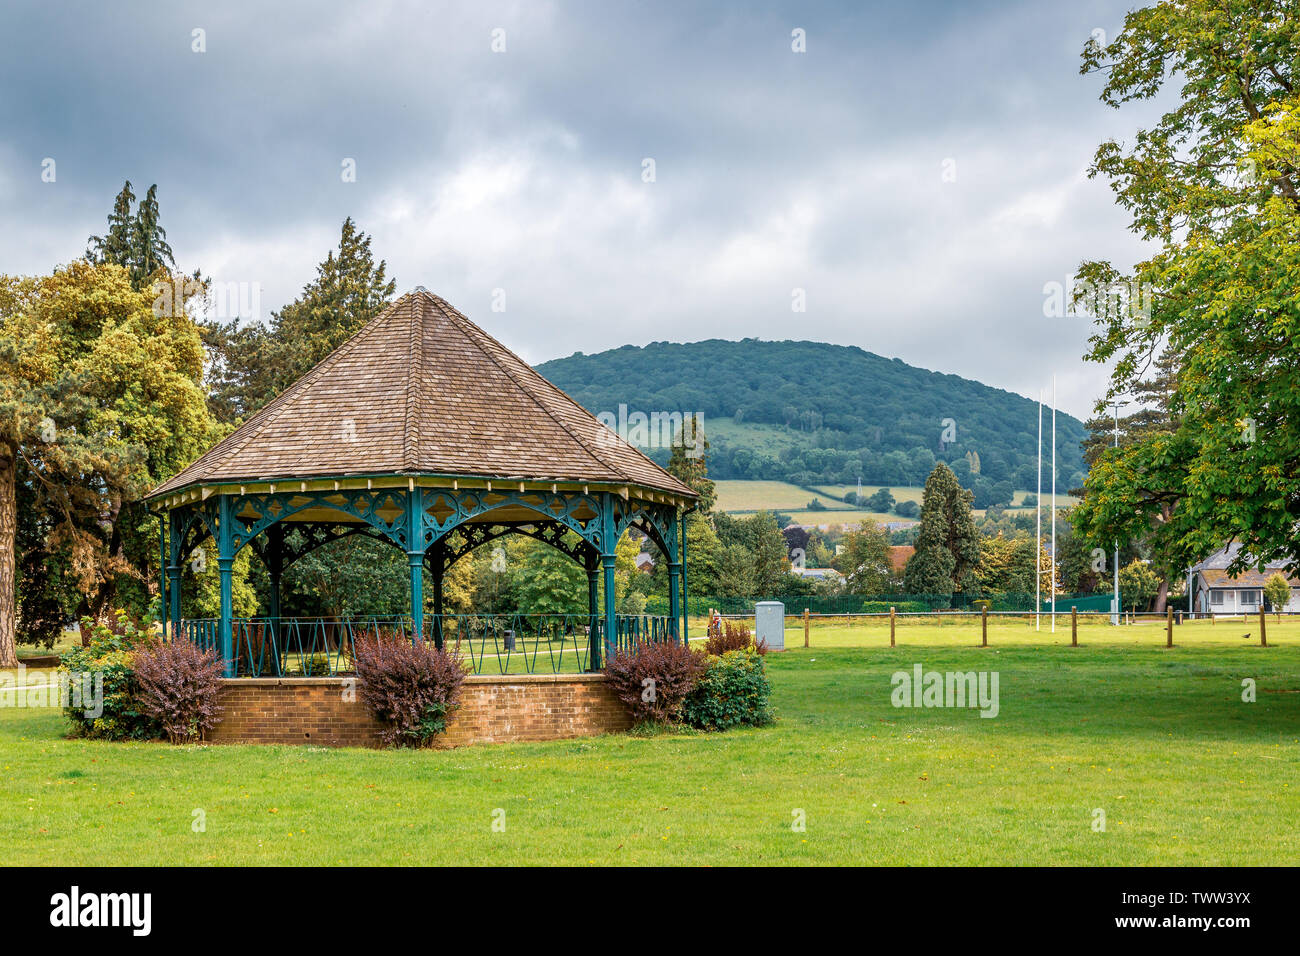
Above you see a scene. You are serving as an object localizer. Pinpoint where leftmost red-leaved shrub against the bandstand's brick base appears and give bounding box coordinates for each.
[134,637,222,744]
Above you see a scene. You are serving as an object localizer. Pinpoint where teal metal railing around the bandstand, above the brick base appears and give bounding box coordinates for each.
[178,614,676,678]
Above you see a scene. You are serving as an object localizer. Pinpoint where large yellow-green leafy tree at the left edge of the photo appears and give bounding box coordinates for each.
[0,260,217,663]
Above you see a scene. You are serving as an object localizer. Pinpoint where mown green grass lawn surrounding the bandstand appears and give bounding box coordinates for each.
[0,622,1300,865]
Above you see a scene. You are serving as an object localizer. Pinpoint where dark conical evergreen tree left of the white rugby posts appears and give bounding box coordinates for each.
[904,462,980,594]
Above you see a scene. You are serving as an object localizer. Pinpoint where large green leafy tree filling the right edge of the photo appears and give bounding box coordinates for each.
[1079,0,1300,582]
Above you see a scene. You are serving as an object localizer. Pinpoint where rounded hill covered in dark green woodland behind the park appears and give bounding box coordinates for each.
[538,338,1086,507]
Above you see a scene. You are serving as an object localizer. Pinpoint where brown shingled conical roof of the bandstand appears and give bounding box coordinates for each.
[147,290,697,498]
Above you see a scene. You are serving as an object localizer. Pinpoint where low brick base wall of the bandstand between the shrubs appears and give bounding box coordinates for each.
[208,674,632,747]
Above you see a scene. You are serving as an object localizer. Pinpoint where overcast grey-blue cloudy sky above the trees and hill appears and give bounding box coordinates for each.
[0,0,1151,415]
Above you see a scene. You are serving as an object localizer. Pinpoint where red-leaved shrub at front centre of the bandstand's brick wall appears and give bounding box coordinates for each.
[356,633,467,747]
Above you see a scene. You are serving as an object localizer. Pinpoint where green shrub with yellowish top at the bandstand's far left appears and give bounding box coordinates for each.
[59,611,163,740]
